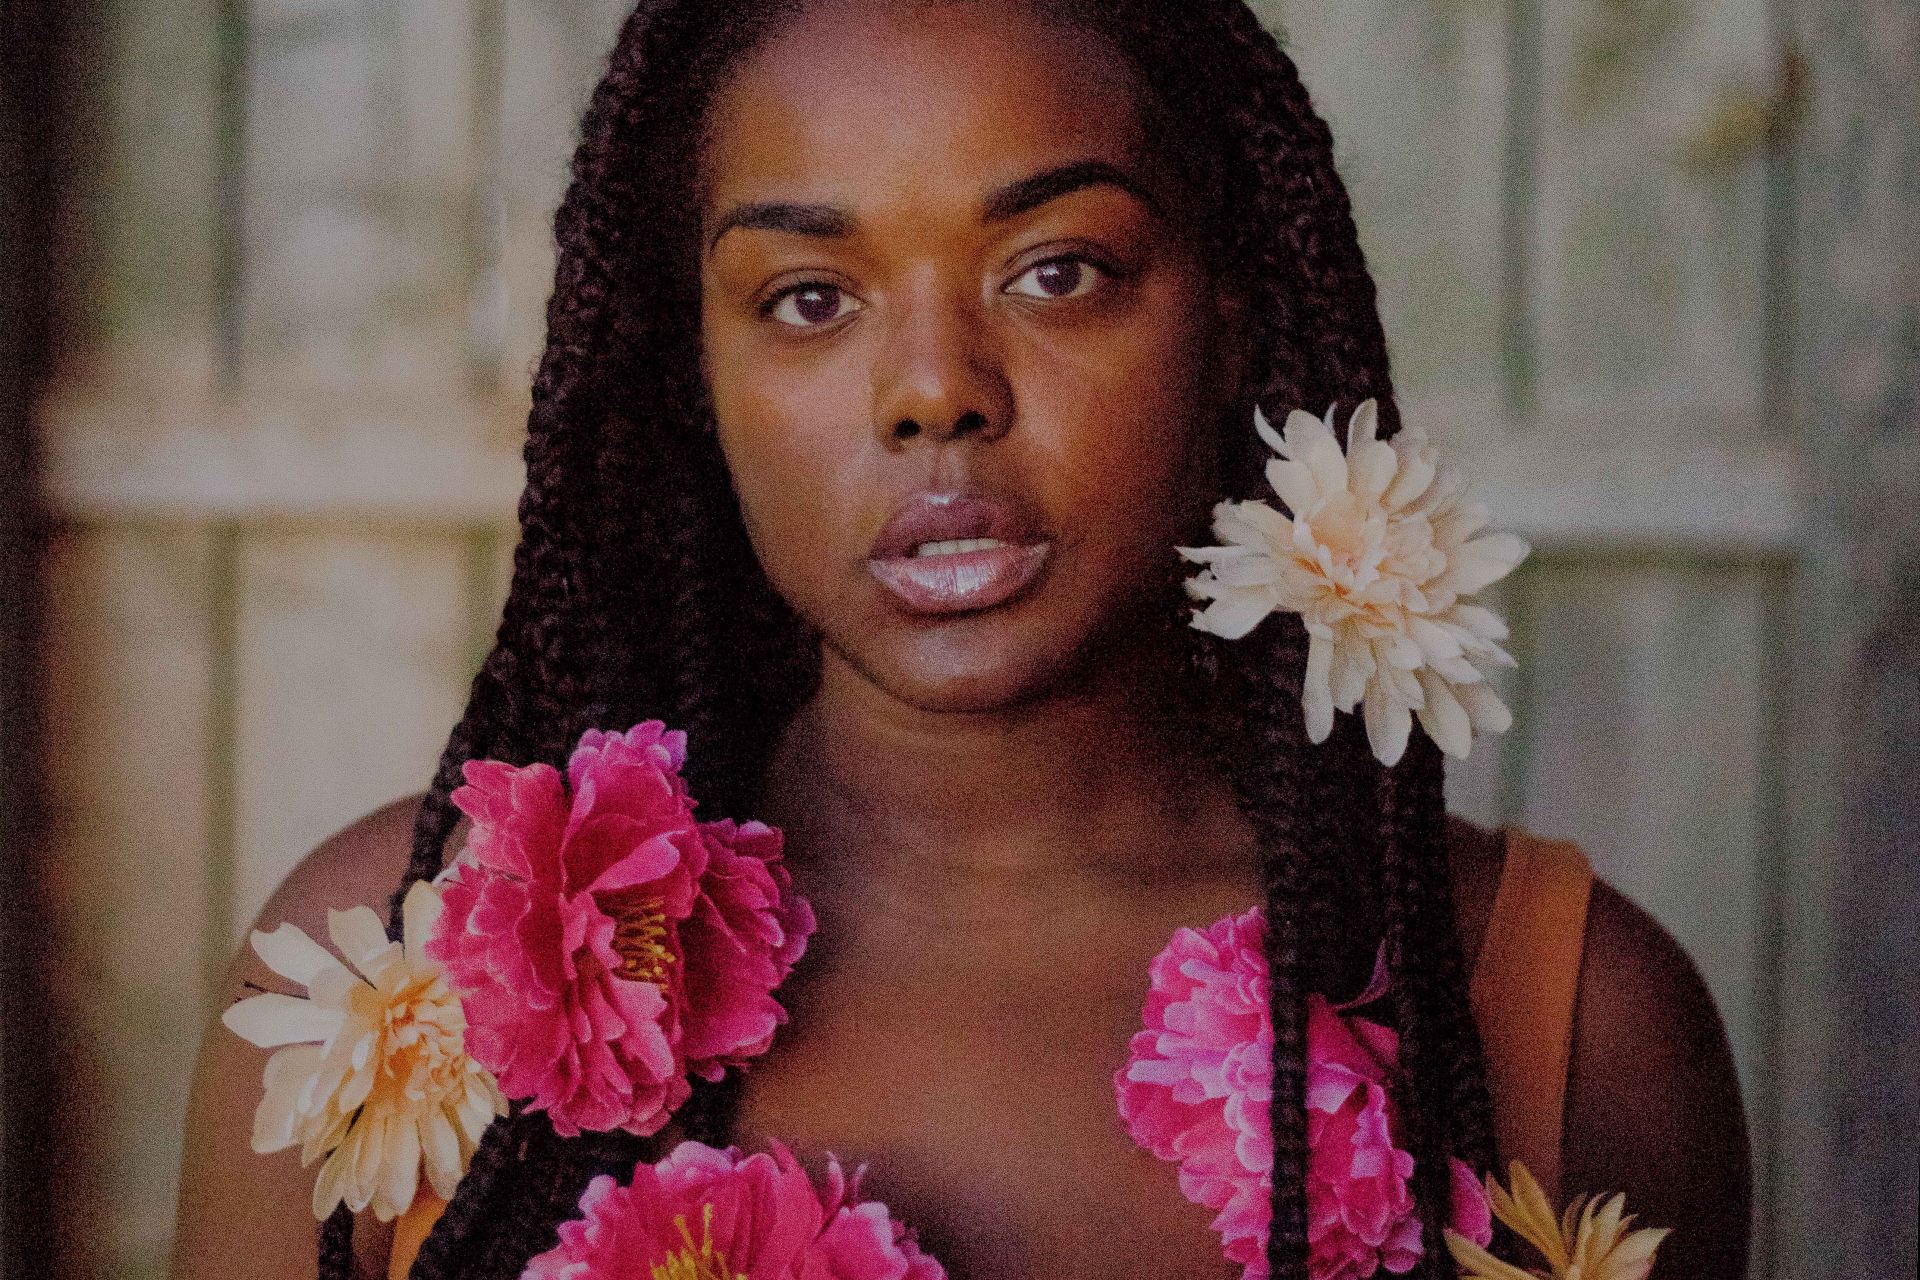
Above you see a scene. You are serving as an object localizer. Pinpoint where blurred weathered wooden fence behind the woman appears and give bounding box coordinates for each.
[0,0,1920,1280]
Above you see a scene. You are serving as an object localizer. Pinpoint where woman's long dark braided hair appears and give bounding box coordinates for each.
[353,0,1494,1280]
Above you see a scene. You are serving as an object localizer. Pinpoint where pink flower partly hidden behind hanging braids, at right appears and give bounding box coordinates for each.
[1114,908,1492,1280]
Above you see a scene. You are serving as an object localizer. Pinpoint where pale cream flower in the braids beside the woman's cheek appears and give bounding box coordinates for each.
[1179,399,1528,766]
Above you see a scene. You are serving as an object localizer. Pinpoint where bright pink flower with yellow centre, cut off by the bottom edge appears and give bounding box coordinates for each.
[522,1142,947,1280]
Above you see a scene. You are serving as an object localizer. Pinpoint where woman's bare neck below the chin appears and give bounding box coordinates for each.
[748,629,1231,889]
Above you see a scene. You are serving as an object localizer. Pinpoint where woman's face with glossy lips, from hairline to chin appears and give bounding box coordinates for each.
[701,0,1236,710]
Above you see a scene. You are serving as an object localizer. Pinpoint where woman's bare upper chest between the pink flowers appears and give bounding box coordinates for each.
[737,890,1238,1280]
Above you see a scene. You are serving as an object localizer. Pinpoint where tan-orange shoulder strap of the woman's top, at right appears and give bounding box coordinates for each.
[1467,825,1594,1201]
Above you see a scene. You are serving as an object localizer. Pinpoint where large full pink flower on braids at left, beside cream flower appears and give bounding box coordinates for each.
[426,722,814,1136]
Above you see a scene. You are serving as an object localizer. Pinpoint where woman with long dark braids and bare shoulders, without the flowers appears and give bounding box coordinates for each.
[177,0,1747,1280]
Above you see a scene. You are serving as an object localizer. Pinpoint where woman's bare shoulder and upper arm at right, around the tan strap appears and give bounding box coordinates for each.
[1448,816,1751,1280]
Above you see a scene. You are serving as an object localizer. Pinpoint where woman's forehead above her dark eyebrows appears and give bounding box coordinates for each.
[703,0,1156,211]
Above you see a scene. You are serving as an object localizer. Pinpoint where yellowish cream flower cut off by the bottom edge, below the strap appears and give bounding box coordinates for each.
[1446,1161,1668,1280]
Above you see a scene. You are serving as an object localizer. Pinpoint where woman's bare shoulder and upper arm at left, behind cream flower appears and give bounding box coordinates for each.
[173,796,432,1280]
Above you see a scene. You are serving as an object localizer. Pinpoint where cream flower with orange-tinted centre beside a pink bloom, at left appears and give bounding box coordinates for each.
[221,881,507,1222]
